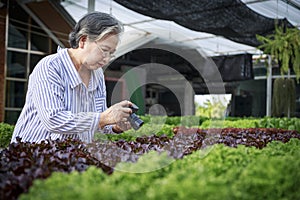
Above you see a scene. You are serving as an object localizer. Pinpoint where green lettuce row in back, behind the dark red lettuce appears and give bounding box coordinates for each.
[0,115,300,148]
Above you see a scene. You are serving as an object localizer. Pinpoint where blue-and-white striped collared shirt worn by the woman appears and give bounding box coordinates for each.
[11,49,112,143]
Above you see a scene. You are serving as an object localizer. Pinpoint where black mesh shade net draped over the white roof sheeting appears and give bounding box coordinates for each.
[115,0,292,46]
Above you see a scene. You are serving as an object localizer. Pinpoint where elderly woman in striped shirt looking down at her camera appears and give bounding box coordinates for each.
[11,12,132,143]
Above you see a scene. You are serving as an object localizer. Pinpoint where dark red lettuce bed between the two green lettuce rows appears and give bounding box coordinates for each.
[0,127,300,199]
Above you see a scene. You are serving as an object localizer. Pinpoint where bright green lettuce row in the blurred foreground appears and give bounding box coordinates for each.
[20,139,300,200]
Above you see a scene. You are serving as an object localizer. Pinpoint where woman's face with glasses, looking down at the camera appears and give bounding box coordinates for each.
[83,35,119,70]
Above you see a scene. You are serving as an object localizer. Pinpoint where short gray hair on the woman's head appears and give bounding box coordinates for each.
[69,12,123,49]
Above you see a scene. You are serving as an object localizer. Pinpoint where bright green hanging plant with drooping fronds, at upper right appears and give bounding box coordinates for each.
[256,26,300,82]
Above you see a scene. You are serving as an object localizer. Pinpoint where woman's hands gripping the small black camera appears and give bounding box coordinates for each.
[99,100,132,131]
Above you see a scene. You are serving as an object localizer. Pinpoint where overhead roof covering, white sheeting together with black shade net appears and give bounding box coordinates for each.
[61,0,300,56]
